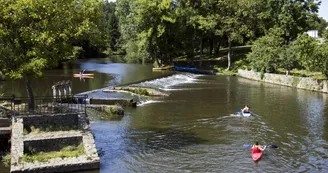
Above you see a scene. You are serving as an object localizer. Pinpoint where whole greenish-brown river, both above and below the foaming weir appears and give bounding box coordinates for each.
[0,60,328,173]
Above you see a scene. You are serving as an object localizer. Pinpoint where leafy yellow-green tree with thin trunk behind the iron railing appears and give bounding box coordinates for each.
[0,0,103,108]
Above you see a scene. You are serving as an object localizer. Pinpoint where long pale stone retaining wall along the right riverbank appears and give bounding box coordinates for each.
[238,69,328,93]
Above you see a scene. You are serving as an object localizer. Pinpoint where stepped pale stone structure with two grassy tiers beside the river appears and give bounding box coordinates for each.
[10,113,100,173]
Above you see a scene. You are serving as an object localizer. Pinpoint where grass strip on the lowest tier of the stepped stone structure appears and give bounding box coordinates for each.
[20,144,85,162]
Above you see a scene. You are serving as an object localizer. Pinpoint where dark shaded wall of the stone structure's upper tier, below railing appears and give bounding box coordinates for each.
[22,113,79,128]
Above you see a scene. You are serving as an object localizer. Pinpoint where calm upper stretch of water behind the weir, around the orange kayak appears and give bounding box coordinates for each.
[0,59,172,97]
